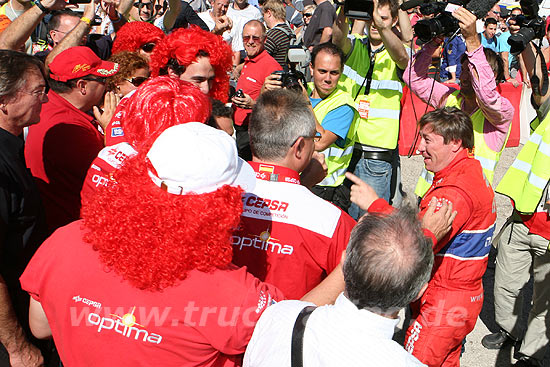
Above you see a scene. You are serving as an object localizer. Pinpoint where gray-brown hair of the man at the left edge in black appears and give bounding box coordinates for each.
[0,50,46,100]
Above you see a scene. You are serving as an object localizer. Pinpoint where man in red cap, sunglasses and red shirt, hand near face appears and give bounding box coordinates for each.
[25,46,118,233]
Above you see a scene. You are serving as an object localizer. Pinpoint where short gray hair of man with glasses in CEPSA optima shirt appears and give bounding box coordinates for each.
[248,89,315,160]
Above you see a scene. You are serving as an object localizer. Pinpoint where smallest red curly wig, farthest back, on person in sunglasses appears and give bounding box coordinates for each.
[112,22,164,55]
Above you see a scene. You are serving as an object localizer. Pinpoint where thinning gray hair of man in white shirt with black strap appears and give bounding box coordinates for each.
[343,204,434,314]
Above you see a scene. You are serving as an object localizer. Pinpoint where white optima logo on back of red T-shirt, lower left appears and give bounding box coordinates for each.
[88,307,162,344]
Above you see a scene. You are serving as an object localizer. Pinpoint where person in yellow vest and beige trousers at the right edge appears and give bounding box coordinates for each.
[481,29,550,366]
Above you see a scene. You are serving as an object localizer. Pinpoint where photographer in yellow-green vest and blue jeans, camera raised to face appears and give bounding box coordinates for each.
[332,0,410,218]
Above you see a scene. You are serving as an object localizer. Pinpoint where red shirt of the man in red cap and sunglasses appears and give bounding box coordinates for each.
[25,91,103,233]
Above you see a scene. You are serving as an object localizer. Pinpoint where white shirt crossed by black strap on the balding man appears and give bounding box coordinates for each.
[243,293,430,367]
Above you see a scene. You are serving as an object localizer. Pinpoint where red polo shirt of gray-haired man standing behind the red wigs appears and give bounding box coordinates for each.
[234,50,281,126]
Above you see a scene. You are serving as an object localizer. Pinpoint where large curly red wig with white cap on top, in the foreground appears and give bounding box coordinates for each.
[82,122,256,291]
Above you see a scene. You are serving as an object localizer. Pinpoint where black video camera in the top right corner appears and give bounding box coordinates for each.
[508,0,546,55]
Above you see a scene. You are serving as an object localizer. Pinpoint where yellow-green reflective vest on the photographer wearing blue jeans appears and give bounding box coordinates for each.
[338,36,403,149]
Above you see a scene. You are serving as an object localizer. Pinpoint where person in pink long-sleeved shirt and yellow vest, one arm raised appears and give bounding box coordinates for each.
[404,8,514,197]
